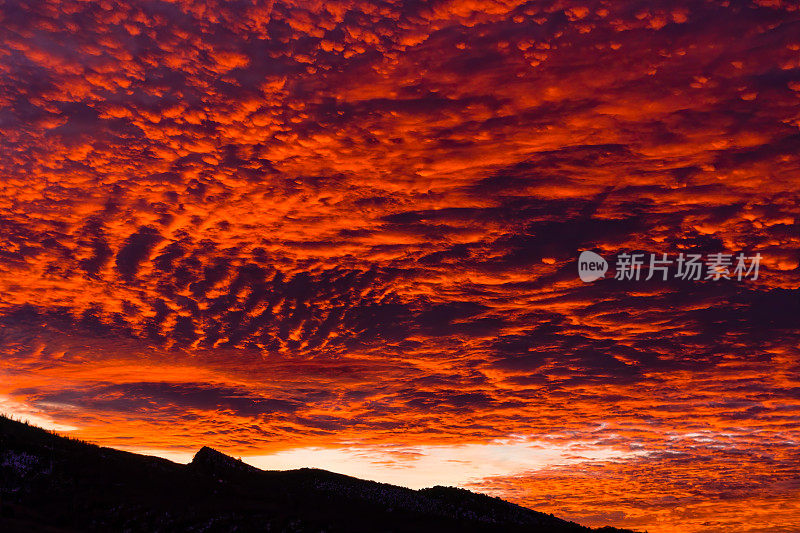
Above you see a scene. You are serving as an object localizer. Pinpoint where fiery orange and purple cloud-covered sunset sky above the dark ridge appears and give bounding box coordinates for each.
[0,0,800,533]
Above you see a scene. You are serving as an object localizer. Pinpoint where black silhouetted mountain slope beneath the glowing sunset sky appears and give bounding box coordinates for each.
[0,417,636,533]
